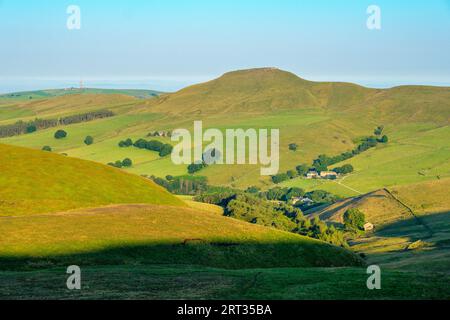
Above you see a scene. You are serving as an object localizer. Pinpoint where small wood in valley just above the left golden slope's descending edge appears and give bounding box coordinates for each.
[150,176,208,195]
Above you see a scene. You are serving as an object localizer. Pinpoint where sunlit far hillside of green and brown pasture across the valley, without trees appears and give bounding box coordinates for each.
[0,68,450,190]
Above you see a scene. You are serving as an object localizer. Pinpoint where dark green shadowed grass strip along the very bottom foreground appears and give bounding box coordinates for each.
[0,265,450,300]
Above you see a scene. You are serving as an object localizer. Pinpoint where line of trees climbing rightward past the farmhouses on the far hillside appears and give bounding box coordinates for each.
[272,126,389,184]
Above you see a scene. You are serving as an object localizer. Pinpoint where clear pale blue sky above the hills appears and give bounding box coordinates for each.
[0,0,450,92]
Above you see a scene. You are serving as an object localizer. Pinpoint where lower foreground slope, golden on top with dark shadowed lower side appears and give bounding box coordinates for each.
[0,205,361,269]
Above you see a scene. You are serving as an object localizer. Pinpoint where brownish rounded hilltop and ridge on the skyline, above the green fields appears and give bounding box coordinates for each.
[149,68,450,123]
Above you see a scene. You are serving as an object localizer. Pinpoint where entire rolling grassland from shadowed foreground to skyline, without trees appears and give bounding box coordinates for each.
[0,68,450,299]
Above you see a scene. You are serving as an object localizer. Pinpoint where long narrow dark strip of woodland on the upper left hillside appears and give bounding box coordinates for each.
[0,110,114,138]
